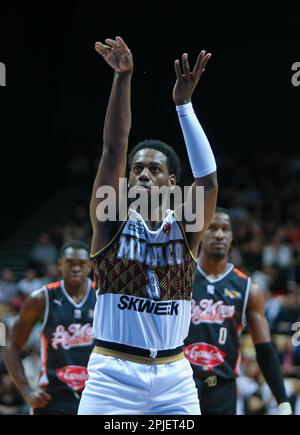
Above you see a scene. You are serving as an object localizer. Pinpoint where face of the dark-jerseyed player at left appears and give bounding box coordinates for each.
[59,248,91,286]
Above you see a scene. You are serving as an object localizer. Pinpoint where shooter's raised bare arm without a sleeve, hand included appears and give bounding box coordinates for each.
[90,37,133,253]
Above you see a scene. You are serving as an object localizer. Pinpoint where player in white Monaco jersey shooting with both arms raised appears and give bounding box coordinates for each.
[79,37,217,415]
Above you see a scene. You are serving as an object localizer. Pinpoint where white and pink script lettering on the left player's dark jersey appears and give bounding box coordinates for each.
[51,323,95,350]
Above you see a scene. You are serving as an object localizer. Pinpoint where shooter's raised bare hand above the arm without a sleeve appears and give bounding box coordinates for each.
[95,36,133,73]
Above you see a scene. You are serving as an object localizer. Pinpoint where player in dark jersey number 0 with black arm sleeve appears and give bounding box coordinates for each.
[184,208,291,415]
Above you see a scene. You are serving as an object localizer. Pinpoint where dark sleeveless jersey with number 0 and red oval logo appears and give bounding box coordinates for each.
[184,264,251,379]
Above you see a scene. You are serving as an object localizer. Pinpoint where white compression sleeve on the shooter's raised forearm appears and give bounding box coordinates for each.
[176,103,217,178]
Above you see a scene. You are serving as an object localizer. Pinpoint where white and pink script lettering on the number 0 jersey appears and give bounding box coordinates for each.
[191,299,235,325]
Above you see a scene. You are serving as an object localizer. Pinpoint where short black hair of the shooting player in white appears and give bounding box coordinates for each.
[128,139,181,182]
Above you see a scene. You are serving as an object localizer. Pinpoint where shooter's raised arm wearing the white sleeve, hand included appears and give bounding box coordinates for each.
[173,51,218,255]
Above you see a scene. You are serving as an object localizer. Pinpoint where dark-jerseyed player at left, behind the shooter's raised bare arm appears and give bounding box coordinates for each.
[5,241,96,415]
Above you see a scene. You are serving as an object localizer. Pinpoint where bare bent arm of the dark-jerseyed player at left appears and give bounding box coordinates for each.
[4,289,51,408]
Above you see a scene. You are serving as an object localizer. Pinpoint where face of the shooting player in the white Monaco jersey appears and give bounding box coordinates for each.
[129,148,175,193]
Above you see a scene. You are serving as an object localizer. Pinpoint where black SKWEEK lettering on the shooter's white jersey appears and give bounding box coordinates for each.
[118,295,179,316]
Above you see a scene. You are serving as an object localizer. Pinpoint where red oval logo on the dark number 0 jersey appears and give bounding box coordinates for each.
[183,343,226,370]
